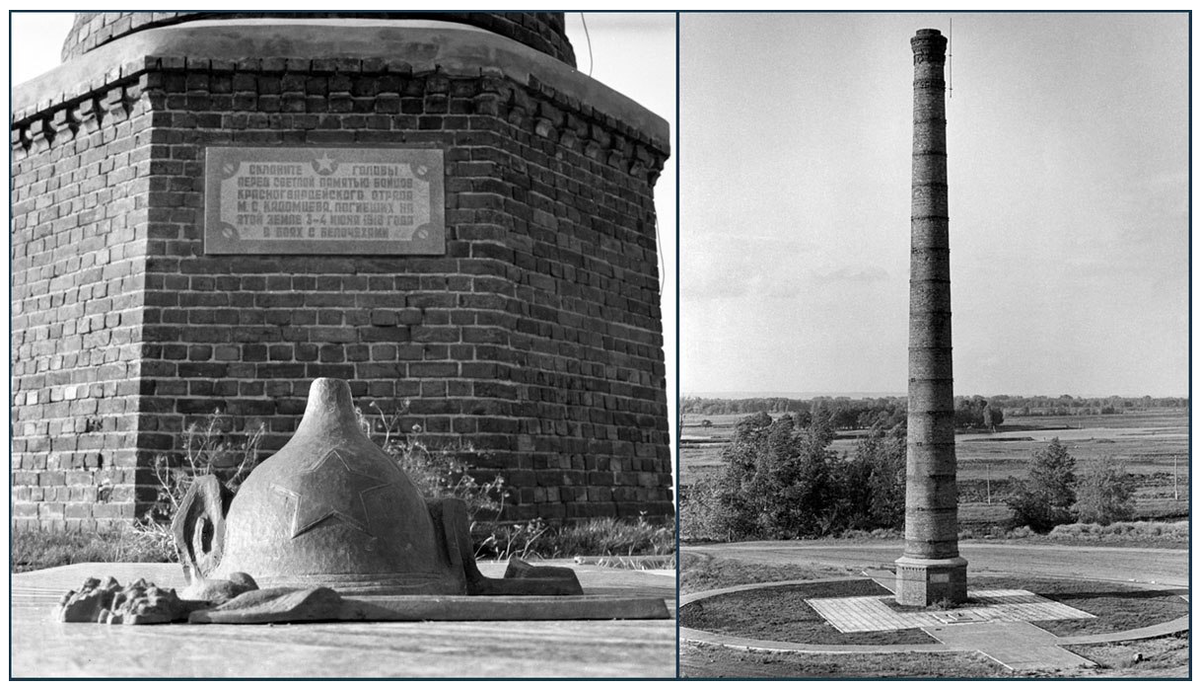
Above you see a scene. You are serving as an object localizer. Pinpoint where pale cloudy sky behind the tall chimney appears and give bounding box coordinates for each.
[679,13,1189,396]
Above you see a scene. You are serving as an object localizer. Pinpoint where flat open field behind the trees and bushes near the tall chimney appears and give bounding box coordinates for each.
[679,410,1190,525]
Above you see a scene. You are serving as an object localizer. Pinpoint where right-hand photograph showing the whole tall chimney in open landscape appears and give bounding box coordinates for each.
[679,12,1192,679]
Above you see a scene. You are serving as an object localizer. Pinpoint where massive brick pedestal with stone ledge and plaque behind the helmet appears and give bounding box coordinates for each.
[11,12,673,529]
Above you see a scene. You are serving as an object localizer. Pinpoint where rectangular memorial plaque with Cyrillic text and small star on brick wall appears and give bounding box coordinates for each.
[204,146,445,255]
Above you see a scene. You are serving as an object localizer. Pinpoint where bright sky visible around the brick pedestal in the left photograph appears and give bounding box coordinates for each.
[10,12,677,417]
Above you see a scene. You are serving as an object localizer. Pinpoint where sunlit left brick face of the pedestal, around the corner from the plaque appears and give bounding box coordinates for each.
[11,83,150,529]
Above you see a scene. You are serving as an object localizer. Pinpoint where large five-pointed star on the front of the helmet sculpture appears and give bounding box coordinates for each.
[271,449,392,538]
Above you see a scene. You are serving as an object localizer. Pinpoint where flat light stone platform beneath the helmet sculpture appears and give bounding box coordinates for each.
[10,562,676,678]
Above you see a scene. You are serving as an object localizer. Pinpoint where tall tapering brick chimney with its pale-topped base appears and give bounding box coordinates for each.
[896,29,966,606]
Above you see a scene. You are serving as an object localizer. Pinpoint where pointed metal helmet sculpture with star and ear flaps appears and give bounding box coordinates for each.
[172,379,582,595]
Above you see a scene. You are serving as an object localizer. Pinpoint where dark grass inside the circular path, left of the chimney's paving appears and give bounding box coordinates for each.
[679,579,937,645]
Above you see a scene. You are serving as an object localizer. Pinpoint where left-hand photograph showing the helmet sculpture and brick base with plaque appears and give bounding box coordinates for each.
[8,8,677,679]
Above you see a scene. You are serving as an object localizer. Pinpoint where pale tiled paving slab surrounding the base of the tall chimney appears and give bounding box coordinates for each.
[805,590,1094,633]
